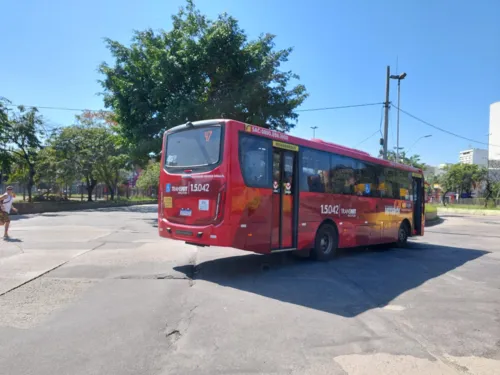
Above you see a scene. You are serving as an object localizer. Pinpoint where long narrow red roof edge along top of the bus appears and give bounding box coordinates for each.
[167,119,422,173]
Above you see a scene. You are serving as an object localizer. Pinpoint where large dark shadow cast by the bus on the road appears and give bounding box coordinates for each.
[175,243,488,317]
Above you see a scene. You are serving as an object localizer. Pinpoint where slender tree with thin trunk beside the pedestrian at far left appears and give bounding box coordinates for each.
[2,106,44,202]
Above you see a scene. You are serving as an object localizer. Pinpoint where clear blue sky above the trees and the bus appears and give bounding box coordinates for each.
[0,0,500,165]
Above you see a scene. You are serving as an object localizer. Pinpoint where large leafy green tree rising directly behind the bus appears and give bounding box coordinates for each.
[99,0,307,164]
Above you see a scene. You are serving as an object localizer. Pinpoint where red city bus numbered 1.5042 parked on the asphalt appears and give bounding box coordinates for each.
[158,120,425,260]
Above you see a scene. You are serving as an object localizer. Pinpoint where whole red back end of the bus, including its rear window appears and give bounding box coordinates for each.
[158,121,232,246]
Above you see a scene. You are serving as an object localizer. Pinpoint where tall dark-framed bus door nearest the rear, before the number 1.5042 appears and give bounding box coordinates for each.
[271,145,299,250]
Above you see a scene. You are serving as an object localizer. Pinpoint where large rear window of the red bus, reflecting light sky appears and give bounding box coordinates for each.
[165,126,221,168]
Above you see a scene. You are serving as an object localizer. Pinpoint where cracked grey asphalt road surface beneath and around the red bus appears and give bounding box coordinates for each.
[0,206,500,375]
